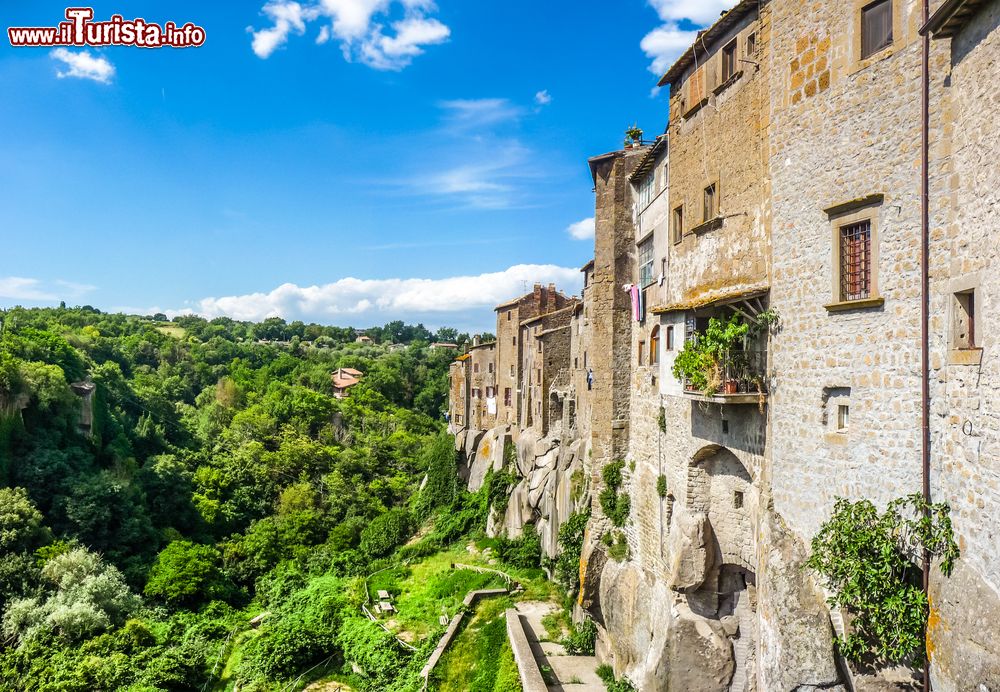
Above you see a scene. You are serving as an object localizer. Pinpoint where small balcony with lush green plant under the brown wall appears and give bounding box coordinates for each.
[672,308,778,405]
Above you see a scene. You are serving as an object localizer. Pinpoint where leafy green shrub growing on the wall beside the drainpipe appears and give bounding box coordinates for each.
[806,494,959,663]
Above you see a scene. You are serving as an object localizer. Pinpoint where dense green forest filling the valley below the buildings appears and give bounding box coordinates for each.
[0,307,540,692]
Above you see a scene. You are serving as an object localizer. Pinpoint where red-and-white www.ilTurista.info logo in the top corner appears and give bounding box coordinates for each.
[7,7,205,48]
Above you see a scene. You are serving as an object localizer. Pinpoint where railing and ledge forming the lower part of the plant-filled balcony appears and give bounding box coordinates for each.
[684,350,767,404]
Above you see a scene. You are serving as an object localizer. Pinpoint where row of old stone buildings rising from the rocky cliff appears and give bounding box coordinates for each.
[452,0,1000,692]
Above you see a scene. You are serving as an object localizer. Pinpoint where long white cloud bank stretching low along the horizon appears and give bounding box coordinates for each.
[161,264,580,324]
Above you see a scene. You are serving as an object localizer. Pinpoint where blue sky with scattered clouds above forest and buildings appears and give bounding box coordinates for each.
[0,0,731,329]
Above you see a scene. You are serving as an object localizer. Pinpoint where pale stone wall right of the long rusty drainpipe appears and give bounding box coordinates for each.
[929,0,1000,692]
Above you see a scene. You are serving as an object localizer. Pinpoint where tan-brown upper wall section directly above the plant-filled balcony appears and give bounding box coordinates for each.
[660,3,772,305]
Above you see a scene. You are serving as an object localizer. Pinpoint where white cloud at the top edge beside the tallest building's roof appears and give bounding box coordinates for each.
[639,0,736,77]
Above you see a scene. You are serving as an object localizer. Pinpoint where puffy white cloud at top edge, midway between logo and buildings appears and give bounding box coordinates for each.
[248,0,451,70]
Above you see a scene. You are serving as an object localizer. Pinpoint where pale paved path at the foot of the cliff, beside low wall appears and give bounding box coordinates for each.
[516,601,606,692]
